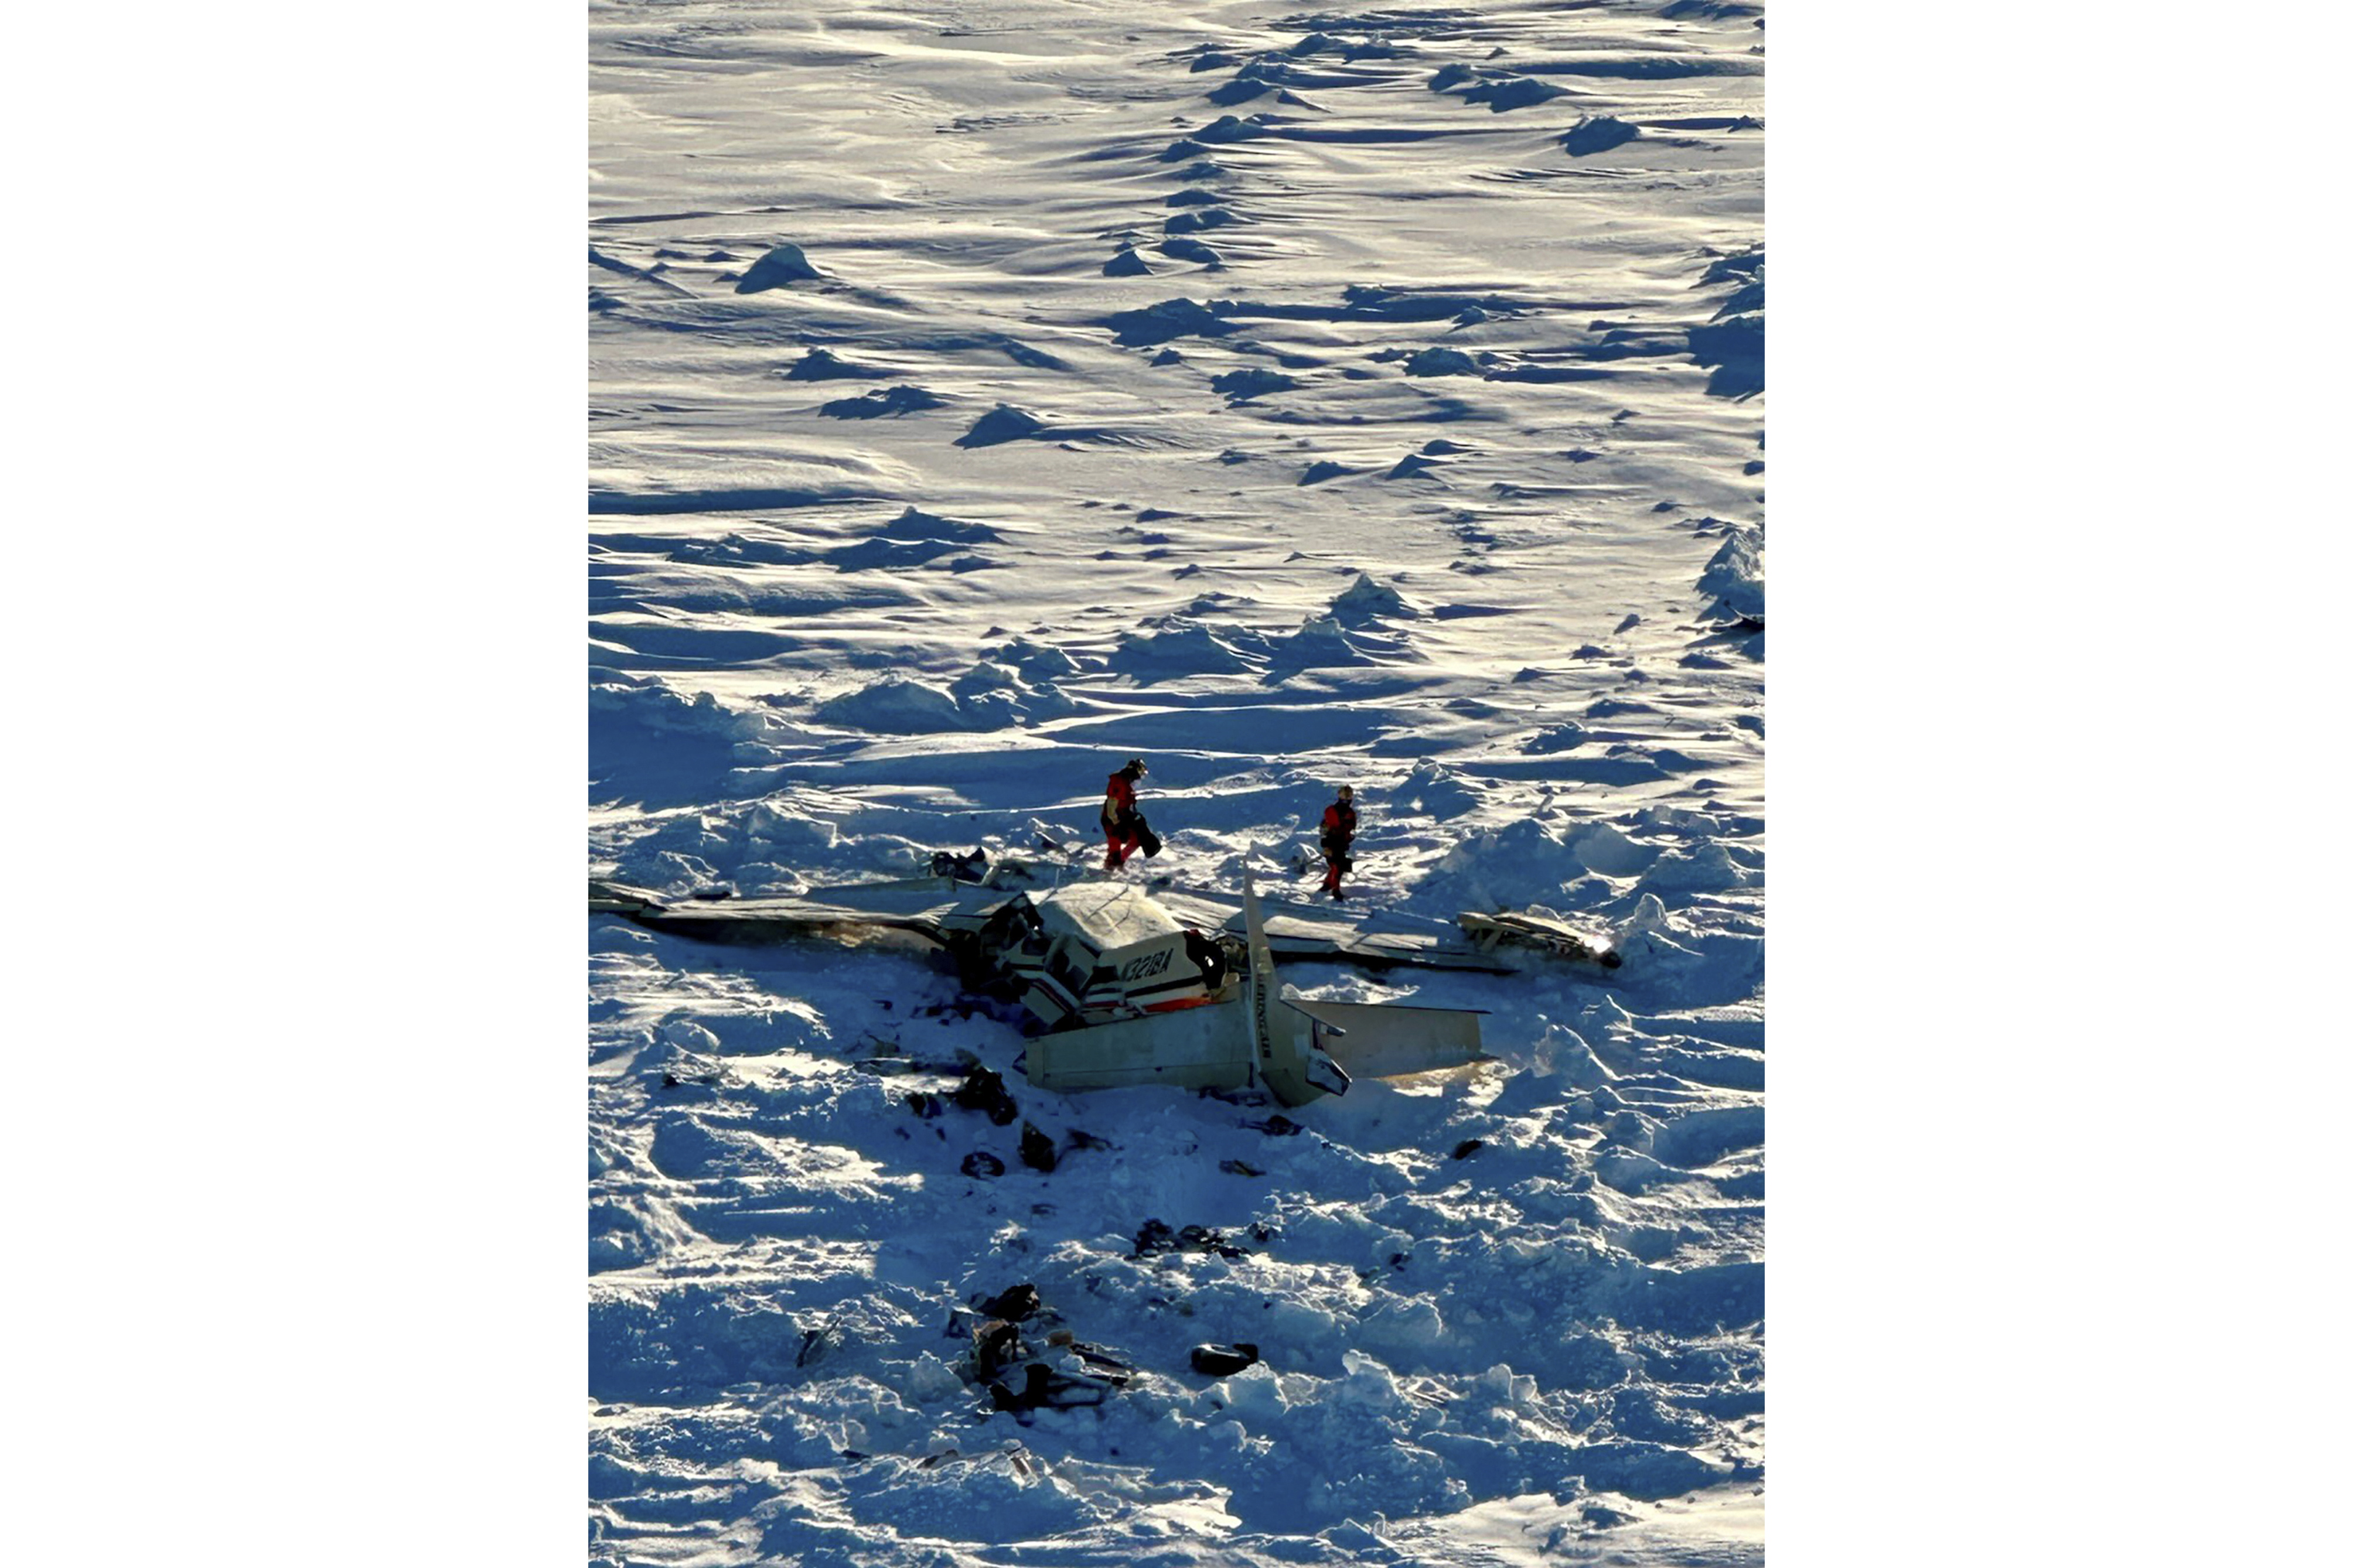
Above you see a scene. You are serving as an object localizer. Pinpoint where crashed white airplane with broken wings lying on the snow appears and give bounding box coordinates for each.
[588,874,1619,1105]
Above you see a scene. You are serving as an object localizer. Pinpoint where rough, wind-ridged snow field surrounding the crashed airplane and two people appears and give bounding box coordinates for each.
[588,0,1765,1563]
